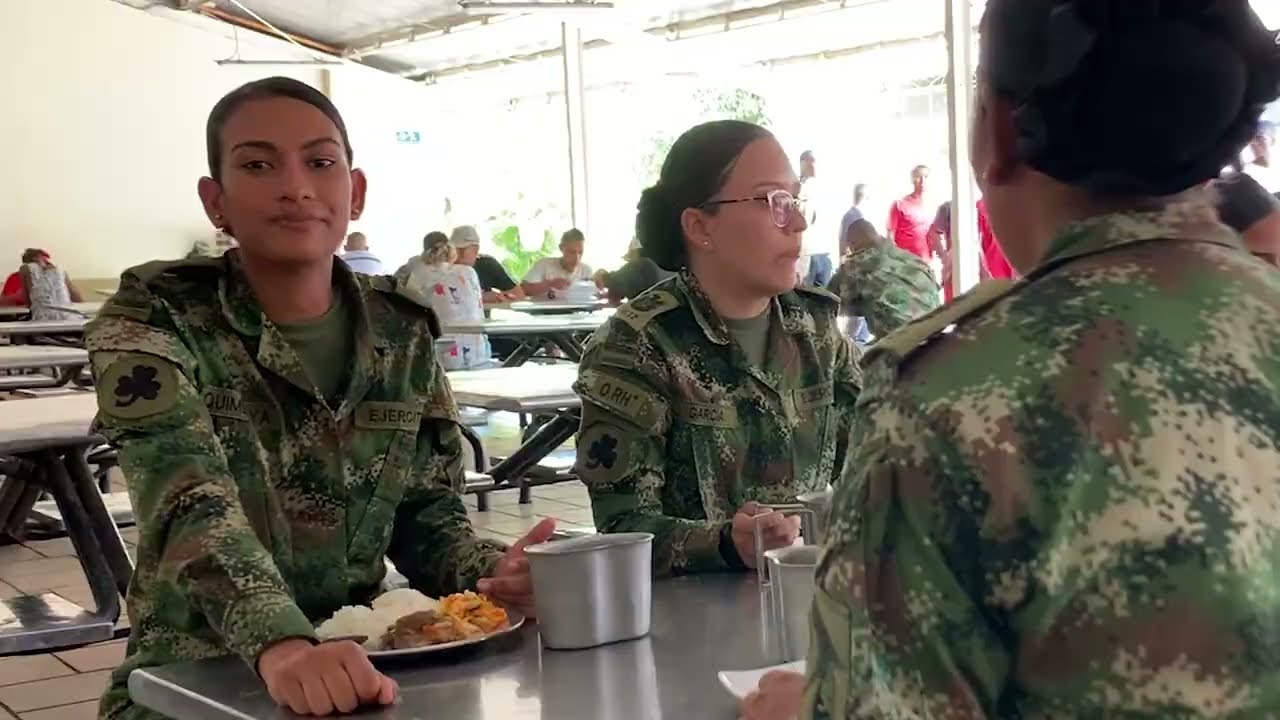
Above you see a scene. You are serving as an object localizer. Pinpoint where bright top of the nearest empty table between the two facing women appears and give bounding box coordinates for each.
[448,363,582,413]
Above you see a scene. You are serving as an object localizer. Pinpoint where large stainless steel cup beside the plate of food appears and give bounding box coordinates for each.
[526,533,653,650]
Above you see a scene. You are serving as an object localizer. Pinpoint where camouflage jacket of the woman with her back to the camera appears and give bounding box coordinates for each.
[804,204,1280,720]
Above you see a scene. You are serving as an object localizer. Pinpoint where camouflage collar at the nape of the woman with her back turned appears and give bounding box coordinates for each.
[1039,201,1244,266]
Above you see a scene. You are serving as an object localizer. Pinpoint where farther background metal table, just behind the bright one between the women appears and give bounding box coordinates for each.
[444,309,613,368]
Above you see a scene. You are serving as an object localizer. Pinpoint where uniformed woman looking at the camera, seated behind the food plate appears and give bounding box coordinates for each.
[86,77,554,720]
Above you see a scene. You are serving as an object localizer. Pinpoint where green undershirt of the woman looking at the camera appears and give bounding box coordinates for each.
[275,288,356,405]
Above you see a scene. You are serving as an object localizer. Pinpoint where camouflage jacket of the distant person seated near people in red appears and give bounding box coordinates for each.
[829,241,941,338]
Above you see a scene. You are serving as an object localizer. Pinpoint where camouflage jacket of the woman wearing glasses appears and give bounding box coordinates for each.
[575,274,860,575]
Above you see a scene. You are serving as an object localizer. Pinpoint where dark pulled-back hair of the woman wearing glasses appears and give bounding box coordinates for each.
[636,120,771,272]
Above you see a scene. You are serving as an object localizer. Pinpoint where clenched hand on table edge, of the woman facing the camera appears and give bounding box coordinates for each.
[257,638,399,715]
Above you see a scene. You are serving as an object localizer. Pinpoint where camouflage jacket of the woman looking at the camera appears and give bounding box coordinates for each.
[86,251,499,717]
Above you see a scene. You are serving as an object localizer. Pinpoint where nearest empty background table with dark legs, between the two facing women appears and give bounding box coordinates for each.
[449,363,582,505]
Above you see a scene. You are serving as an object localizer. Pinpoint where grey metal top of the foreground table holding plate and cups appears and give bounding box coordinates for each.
[129,574,780,720]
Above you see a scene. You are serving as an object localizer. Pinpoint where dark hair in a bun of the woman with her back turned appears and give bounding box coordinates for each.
[982,0,1280,196]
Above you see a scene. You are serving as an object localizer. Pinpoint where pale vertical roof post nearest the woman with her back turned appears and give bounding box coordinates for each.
[946,0,982,296]
